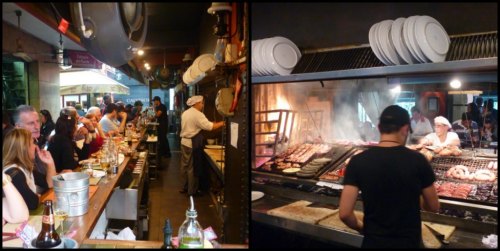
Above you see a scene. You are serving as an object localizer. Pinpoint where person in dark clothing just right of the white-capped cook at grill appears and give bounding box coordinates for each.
[451,112,479,147]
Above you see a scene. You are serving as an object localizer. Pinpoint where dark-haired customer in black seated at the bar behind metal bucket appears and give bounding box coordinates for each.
[49,115,78,173]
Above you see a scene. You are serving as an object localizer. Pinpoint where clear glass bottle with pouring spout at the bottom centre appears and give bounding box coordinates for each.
[179,196,204,248]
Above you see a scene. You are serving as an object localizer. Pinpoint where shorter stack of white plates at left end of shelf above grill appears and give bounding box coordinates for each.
[252,37,302,76]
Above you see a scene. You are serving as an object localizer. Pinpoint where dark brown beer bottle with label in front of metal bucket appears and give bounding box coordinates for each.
[35,200,61,248]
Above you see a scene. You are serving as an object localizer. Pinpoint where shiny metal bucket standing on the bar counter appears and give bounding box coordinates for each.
[52,172,89,217]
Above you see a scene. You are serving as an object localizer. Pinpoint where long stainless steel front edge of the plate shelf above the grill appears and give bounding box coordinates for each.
[252,57,498,84]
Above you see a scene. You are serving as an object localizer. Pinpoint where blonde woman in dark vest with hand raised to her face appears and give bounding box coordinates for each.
[2,128,56,210]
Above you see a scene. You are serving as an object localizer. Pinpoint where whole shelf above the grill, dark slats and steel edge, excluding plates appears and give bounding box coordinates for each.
[252,31,498,84]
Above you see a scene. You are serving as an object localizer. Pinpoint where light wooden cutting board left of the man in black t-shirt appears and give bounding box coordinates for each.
[267,200,338,224]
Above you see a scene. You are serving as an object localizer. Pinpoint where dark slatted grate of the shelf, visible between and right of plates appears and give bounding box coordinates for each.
[292,31,498,74]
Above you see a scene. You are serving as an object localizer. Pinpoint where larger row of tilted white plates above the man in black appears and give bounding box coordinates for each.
[368,16,450,65]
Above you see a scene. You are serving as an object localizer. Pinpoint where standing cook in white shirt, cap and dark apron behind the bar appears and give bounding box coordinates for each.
[179,96,225,196]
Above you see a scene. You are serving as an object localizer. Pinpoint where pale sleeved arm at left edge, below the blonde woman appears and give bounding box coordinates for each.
[2,173,29,226]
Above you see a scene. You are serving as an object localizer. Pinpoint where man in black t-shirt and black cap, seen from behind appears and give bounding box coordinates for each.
[339,105,439,248]
